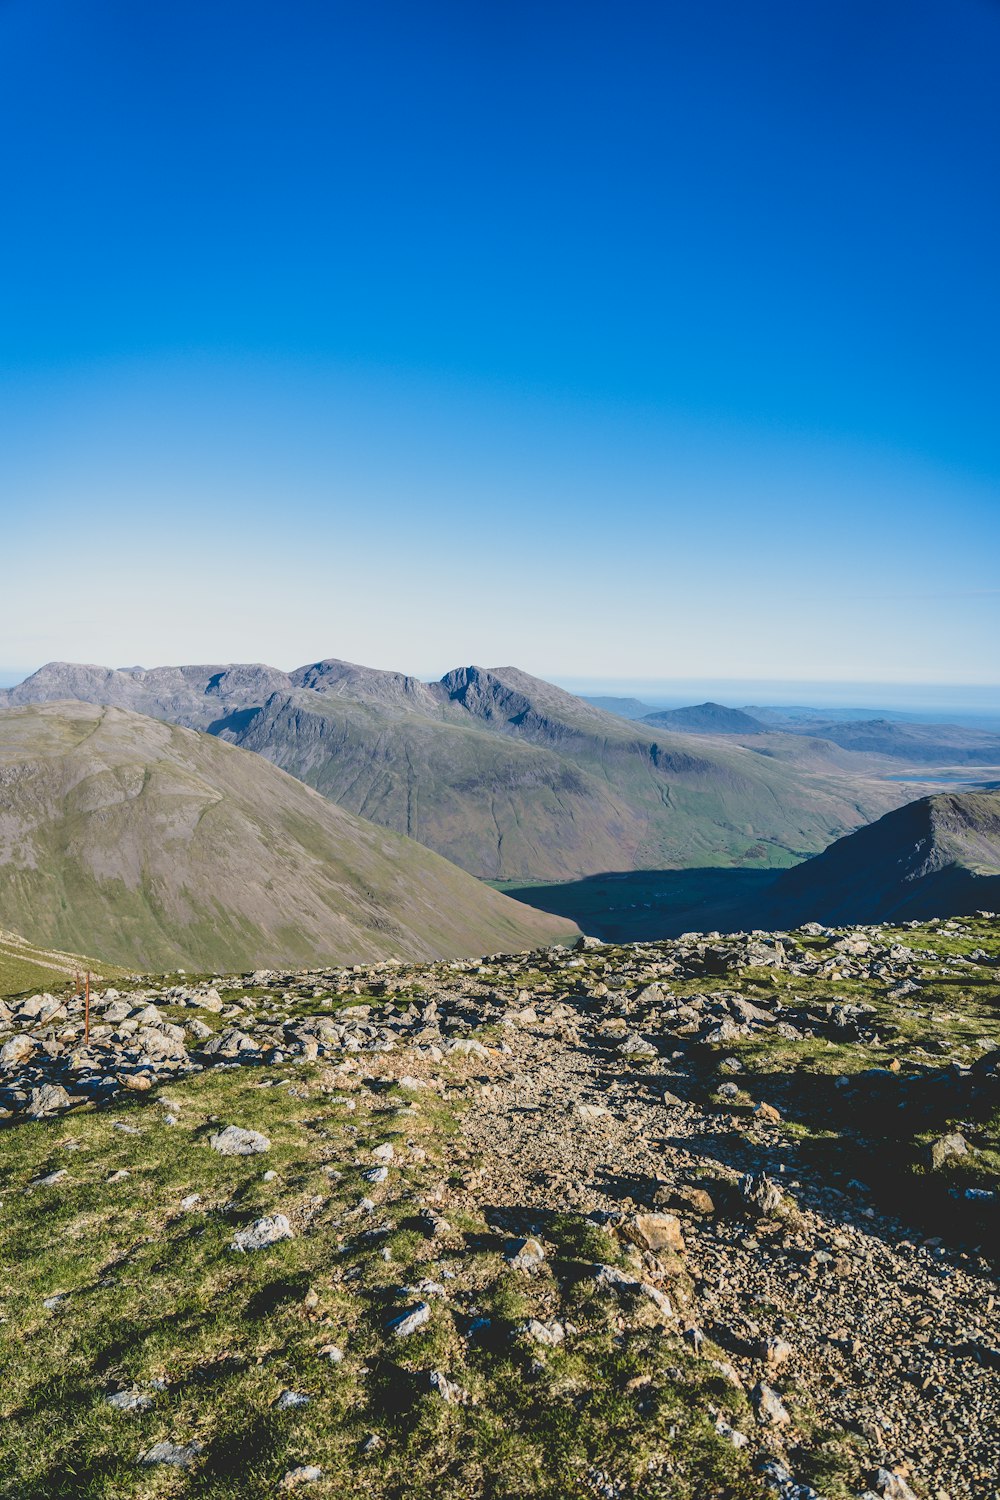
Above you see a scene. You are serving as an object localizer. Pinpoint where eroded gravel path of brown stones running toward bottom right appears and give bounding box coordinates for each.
[465,1014,1000,1500]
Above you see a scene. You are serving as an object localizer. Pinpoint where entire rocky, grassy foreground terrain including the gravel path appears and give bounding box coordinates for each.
[0,915,1000,1500]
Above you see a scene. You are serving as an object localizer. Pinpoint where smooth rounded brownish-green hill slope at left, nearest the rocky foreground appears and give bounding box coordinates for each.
[0,702,574,971]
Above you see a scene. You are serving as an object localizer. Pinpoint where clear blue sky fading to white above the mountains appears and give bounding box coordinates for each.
[0,0,1000,684]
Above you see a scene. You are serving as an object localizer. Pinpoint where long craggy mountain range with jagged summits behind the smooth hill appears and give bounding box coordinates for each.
[0,660,906,881]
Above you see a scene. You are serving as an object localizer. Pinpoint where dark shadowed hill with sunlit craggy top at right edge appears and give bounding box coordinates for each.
[768,791,1000,924]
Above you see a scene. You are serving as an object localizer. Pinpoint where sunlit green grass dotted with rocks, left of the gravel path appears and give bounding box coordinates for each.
[0,1059,759,1500]
